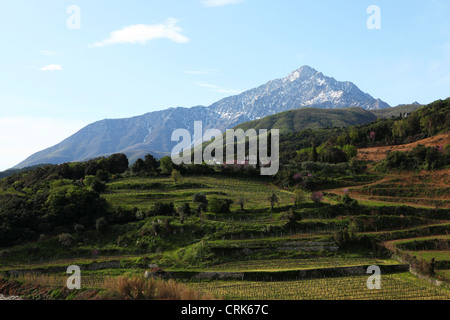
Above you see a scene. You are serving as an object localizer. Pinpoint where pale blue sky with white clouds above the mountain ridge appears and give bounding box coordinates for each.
[0,0,450,170]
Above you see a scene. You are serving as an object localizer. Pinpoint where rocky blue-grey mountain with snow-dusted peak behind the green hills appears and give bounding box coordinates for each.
[15,66,389,168]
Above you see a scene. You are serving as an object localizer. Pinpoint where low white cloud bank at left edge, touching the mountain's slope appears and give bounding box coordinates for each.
[0,117,87,171]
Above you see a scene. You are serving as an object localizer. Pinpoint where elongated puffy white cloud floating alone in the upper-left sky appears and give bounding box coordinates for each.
[91,18,189,47]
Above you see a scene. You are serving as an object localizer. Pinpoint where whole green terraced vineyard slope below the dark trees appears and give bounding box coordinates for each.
[0,171,450,300]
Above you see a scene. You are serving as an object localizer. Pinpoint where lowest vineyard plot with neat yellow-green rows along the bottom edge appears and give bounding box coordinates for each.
[192,274,450,300]
